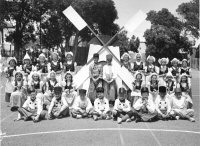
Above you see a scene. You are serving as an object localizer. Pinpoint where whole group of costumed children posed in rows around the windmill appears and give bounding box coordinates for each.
[2,52,195,124]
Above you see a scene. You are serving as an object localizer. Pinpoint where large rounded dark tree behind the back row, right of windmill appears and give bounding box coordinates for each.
[144,9,191,59]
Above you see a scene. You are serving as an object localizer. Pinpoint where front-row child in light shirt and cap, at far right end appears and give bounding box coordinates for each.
[170,88,195,122]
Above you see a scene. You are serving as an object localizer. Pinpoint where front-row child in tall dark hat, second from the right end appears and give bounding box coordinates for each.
[155,86,171,120]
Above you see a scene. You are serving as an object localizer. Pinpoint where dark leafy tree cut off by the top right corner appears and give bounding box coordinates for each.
[176,0,199,38]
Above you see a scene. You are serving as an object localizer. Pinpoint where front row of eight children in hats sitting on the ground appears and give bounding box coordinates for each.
[16,86,195,124]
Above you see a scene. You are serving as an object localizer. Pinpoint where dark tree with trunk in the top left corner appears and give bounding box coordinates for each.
[2,0,51,60]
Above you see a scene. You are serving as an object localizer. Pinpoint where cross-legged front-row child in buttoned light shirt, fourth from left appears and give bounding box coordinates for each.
[93,87,111,121]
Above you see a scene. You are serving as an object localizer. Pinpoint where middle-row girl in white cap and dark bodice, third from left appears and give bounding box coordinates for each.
[43,71,59,110]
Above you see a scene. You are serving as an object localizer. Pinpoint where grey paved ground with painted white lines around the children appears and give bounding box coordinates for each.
[1,70,200,146]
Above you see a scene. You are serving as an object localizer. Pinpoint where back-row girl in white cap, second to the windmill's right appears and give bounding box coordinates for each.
[133,53,144,73]
